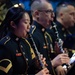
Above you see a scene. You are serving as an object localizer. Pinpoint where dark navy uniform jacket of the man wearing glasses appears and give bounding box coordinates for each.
[30,21,54,75]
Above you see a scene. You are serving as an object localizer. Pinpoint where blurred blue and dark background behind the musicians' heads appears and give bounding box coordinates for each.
[0,0,75,24]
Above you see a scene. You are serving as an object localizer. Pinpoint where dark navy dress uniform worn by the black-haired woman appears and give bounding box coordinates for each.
[0,33,41,75]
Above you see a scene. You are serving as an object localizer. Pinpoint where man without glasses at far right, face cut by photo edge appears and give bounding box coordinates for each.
[53,3,75,57]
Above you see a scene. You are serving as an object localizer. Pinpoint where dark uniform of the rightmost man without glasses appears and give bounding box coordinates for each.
[52,21,75,57]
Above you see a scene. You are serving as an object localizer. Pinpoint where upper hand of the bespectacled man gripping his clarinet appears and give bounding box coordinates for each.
[51,53,70,67]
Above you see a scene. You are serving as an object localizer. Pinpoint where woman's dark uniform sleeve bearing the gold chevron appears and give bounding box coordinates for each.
[0,47,12,75]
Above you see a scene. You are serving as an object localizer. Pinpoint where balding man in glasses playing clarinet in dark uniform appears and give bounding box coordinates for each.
[30,0,69,75]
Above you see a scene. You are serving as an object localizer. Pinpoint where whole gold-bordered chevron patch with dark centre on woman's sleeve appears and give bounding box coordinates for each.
[0,59,12,73]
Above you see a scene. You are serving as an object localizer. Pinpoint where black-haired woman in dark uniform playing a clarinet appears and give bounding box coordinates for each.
[0,6,50,75]
